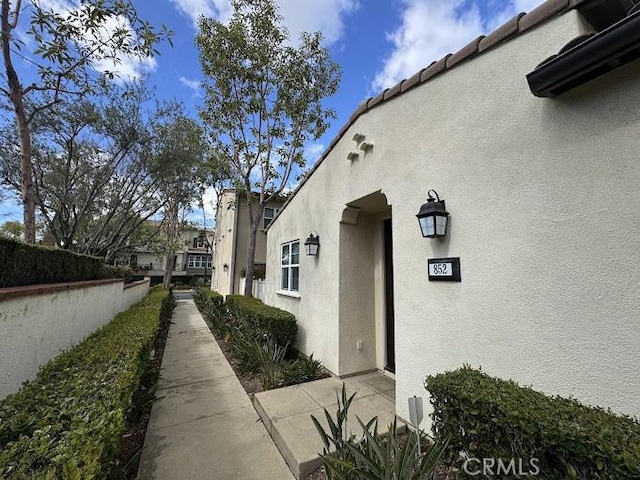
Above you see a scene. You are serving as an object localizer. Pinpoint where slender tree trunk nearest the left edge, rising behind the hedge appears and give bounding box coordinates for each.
[0,0,36,243]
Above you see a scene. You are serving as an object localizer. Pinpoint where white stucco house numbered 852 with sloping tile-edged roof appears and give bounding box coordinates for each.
[266,0,640,424]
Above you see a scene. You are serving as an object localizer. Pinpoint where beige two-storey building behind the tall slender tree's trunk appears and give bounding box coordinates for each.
[211,189,283,295]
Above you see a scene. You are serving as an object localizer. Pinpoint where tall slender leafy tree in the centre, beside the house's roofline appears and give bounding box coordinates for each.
[196,0,340,296]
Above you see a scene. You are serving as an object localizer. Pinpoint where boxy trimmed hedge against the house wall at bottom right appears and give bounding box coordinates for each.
[425,366,640,480]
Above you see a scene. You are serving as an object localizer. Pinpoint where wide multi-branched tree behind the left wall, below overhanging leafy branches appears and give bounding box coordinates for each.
[0,85,173,261]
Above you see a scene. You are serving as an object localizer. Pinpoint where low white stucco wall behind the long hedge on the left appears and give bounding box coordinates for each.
[0,279,149,399]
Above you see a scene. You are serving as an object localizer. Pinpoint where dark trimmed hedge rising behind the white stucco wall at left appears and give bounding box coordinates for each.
[0,237,130,288]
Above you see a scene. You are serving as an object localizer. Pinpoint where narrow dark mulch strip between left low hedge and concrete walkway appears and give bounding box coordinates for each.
[107,300,171,480]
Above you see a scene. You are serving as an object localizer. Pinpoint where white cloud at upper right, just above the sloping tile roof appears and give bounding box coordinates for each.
[371,0,542,93]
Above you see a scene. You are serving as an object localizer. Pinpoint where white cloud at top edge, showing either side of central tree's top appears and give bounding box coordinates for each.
[171,0,359,45]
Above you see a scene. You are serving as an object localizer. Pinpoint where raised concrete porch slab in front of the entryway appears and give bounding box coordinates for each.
[253,372,395,479]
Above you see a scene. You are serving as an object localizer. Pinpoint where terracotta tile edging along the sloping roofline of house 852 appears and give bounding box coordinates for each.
[271,0,587,224]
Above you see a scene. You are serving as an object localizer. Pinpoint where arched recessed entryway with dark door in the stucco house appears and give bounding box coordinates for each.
[338,191,395,375]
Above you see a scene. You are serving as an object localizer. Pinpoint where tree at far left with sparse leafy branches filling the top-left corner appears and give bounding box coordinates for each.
[0,0,171,243]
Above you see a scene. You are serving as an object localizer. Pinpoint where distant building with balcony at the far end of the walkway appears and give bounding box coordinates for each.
[127,229,215,284]
